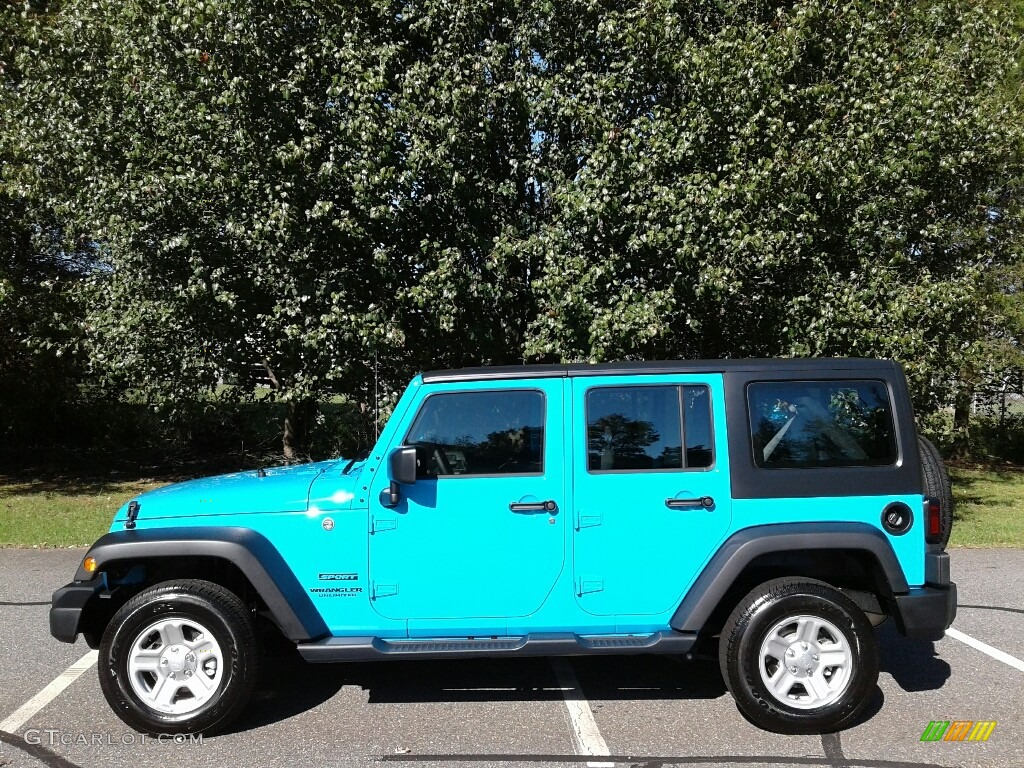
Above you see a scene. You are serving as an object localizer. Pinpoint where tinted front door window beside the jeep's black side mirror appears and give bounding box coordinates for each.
[406,390,544,477]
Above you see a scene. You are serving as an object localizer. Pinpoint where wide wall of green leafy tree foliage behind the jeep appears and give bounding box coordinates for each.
[0,0,1022,452]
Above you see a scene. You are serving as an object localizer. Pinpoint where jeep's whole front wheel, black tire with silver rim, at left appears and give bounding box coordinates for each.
[98,580,259,734]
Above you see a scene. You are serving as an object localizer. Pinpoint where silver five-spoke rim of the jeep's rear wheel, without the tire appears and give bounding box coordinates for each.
[759,614,853,710]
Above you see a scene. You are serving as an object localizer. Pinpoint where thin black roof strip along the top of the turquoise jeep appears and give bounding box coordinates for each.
[423,357,898,384]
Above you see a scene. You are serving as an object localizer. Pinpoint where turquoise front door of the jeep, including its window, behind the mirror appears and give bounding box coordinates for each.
[370,378,567,635]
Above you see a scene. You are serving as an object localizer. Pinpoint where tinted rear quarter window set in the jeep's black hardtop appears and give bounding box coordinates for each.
[748,381,896,468]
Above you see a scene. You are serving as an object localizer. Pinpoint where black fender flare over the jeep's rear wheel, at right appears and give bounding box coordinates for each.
[669,522,910,632]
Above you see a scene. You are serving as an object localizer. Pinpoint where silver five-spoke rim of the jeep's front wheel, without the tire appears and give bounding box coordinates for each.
[128,618,224,715]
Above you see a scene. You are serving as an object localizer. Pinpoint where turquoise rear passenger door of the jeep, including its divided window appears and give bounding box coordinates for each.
[572,375,732,615]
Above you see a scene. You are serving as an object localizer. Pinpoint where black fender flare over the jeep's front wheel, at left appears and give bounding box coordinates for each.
[75,525,329,642]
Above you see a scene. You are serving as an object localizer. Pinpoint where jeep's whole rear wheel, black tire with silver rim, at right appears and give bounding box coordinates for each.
[719,579,879,733]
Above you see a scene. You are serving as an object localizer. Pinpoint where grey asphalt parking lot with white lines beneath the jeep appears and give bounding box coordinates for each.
[0,550,1024,768]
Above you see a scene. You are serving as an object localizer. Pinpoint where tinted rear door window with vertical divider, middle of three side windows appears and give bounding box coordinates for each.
[587,386,714,472]
